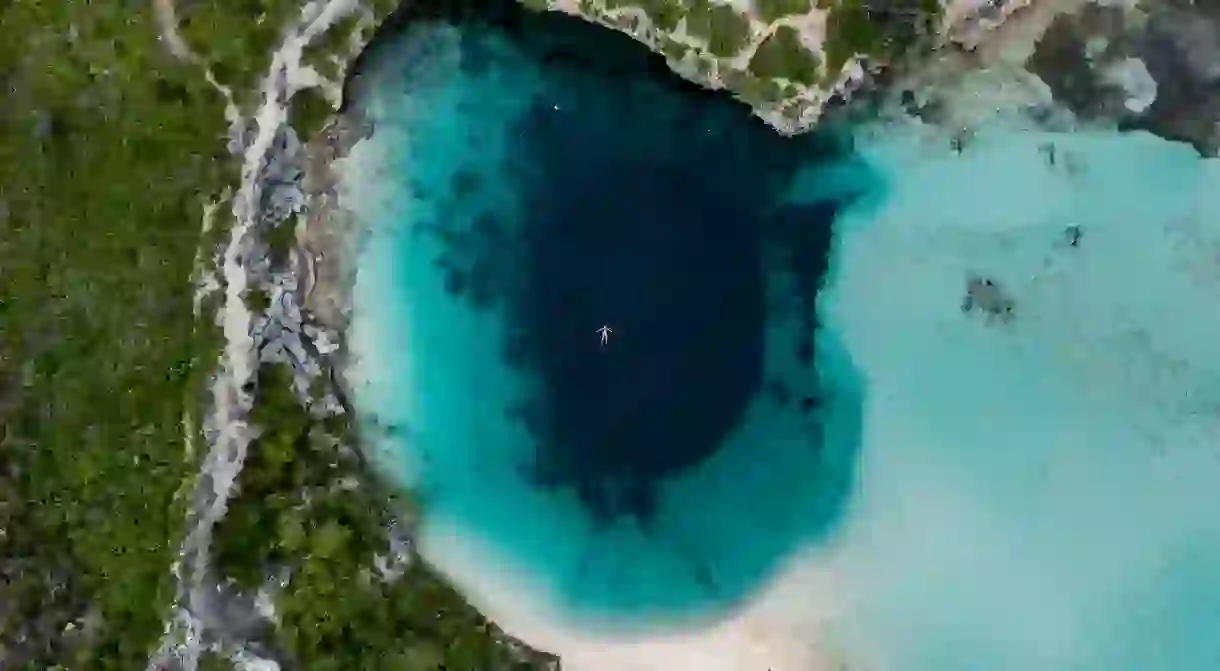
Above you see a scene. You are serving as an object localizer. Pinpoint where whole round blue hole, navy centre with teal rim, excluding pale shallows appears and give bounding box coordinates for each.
[348,2,878,626]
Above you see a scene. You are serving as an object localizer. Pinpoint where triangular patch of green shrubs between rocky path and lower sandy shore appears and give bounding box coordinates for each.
[214,366,553,671]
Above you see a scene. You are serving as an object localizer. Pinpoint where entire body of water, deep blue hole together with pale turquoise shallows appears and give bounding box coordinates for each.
[344,0,1220,671]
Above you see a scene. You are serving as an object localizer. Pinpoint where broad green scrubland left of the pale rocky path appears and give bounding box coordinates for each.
[0,2,235,670]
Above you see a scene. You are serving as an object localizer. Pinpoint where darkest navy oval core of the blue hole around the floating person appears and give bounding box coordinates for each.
[526,155,764,512]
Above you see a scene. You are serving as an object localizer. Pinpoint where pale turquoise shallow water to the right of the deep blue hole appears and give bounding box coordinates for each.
[821,127,1220,670]
